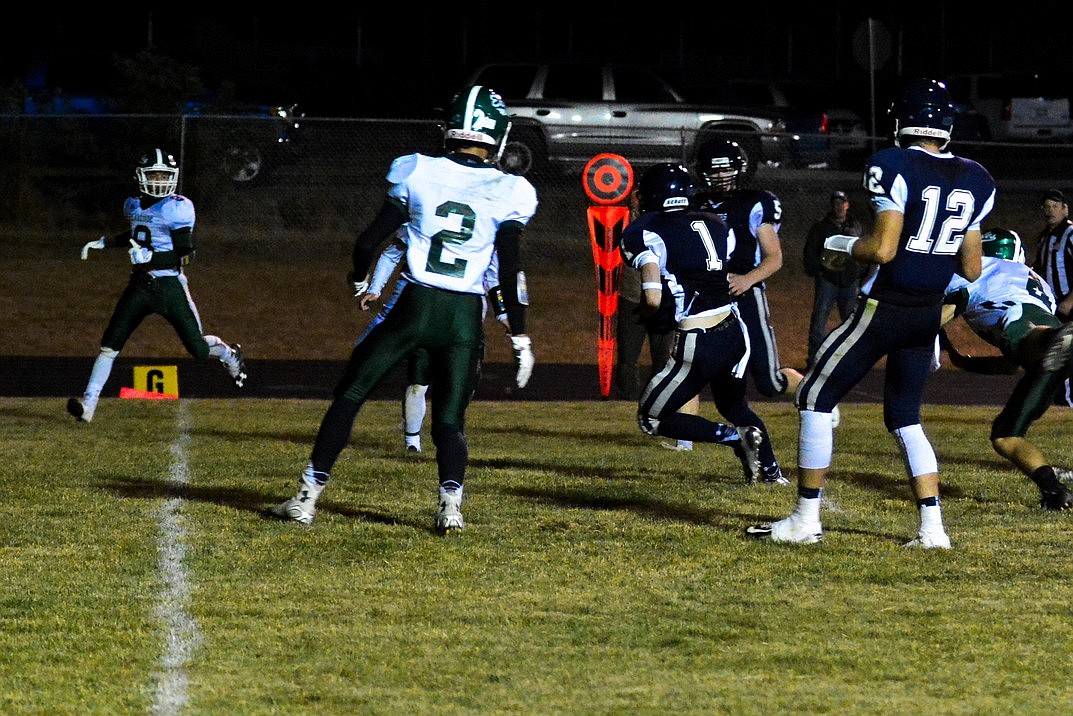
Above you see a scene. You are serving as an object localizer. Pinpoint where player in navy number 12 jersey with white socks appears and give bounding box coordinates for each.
[746,79,995,549]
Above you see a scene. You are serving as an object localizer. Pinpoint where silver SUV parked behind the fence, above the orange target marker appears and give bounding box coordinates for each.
[469,62,790,174]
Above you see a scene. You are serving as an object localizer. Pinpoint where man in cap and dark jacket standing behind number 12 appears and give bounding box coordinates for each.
[804,191,863,368]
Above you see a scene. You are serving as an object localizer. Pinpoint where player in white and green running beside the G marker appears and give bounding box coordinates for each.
[67,148,246,423]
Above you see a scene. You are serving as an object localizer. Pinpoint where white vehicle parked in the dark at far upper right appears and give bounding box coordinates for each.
[946,72,1073,142]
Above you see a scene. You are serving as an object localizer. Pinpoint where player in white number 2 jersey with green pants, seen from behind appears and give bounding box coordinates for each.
[271,85,537,535]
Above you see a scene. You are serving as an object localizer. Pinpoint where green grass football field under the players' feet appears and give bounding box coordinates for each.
[0,398,1073,714]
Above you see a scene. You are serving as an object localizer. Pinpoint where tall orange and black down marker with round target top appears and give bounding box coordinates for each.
[582,154,633,398]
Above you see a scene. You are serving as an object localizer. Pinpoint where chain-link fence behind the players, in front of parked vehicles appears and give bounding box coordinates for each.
[6,115,1070,262]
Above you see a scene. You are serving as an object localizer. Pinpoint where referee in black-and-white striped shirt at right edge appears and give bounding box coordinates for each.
[1032,189,1073,406]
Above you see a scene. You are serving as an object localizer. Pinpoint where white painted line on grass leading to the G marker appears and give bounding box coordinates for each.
[151,400,201,715]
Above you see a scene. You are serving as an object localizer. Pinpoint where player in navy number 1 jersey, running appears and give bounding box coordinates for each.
[621,164,766,483]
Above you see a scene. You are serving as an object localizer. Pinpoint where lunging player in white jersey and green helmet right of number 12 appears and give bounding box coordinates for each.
[943,229,1073,510]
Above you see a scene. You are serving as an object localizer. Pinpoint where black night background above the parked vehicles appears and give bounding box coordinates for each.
[6,2,1073,117]
